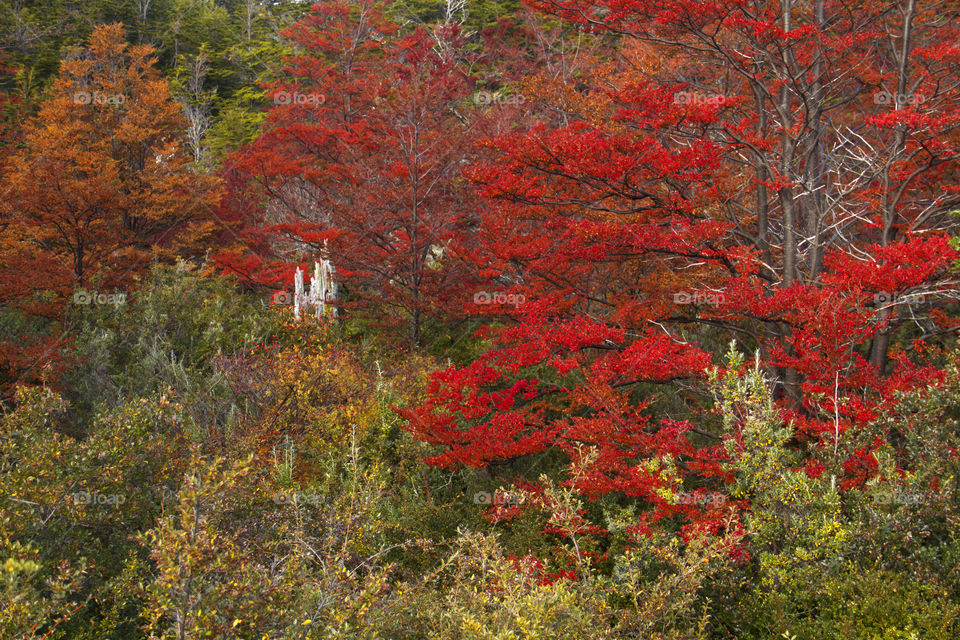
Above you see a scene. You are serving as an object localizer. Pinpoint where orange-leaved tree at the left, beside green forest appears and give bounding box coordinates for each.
[0,24,219,315]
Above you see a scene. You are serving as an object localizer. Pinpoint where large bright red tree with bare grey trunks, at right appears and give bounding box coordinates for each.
[406,0,960,536]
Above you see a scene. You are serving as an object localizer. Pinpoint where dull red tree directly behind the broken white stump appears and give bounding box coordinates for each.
[220,2,484,346]
